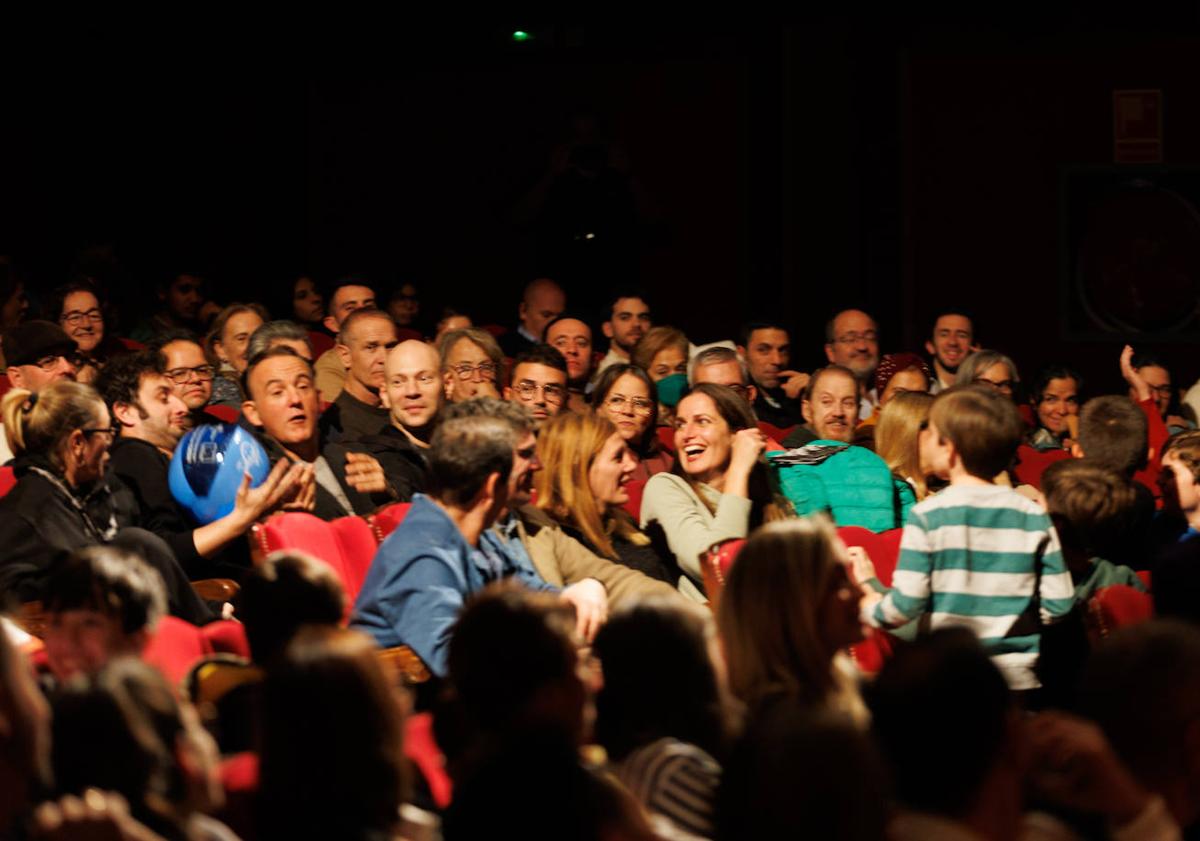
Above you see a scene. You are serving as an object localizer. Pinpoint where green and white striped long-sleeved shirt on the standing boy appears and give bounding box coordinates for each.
[864,485,1075,689]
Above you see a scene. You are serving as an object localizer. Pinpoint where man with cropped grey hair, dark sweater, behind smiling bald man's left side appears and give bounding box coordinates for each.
[322,310,400,441]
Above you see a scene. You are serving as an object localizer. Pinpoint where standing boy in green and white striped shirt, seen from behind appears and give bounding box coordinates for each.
[863,385,1074,690]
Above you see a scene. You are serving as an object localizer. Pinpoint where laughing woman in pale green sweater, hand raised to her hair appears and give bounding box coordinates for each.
[641,384,770,601]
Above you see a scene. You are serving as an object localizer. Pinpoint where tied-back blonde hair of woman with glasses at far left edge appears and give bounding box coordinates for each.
[0,380,104,469]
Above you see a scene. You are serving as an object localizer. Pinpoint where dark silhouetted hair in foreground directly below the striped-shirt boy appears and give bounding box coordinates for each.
[865,627,1012,817]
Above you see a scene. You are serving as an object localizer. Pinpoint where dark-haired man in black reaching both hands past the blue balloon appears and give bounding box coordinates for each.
[96,352,307,581]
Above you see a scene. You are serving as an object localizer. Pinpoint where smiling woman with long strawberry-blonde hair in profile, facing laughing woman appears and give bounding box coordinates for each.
[534,413,678,582]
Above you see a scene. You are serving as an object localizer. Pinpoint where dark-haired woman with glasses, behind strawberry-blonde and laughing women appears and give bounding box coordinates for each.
[592,362,674,482]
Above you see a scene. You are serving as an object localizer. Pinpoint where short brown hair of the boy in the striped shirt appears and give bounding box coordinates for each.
[929,385,1025,480]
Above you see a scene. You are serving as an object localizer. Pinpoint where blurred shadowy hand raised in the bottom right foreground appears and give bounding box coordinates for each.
[1028,713,1150,827]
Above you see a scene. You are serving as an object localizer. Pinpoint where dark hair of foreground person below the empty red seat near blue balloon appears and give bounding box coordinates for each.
[238,551,346,665]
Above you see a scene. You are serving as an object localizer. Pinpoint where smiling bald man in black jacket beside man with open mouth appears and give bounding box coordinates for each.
[361,340,445,503]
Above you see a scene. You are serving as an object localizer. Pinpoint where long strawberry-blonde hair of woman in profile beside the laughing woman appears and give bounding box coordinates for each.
[536,412,649,560]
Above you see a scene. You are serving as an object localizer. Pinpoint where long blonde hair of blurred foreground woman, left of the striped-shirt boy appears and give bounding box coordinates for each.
[716,517,866,721]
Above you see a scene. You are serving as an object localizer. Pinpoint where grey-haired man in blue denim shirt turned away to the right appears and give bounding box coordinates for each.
[352,398,558,677]
